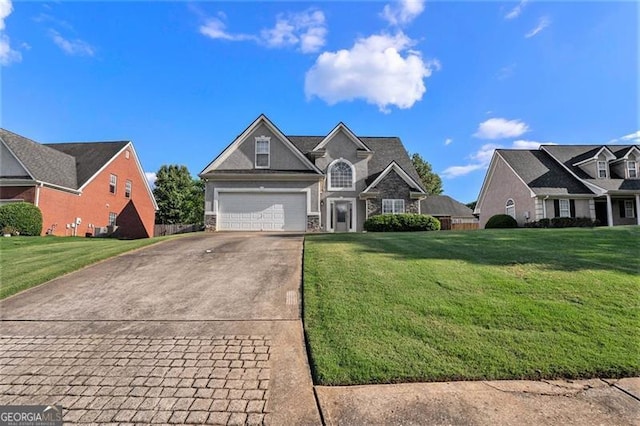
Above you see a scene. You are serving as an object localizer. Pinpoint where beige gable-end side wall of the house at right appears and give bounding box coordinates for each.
[479,154,536,228]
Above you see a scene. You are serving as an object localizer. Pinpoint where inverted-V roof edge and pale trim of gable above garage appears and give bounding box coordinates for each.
[200,114,322,175]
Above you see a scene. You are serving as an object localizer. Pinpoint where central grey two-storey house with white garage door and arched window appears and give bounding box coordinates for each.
[200,115,426,232]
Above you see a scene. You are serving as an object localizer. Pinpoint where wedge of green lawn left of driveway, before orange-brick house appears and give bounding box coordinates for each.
[0,237,172,299]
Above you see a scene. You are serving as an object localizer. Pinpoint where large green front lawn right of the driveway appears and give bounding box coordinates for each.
[304,226,640,385]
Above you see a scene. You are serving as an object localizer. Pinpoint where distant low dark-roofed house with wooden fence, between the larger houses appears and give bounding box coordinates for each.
[420,195,478,231]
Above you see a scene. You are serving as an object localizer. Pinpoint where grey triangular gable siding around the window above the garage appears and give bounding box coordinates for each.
[217,124,310,170]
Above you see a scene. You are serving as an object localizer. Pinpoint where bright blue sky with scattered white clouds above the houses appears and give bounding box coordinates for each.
[0,0,640,202]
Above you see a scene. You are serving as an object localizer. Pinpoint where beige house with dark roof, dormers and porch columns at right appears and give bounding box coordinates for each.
[475,145,640,227]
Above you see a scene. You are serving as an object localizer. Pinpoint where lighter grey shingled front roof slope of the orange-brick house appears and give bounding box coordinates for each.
[0,129,78,190]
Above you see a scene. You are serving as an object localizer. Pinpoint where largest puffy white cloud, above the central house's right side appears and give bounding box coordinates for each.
[305,32,440,112]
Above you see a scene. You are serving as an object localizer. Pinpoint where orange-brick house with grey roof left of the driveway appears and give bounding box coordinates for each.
[0,129,158,238]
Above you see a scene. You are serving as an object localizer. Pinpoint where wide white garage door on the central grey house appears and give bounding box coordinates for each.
[218,192,307,231]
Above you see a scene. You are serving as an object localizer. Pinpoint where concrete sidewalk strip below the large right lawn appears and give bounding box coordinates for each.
[315,378,640,425]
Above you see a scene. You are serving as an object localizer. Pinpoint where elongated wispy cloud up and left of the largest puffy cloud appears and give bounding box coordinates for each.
[199,9,327,53]
